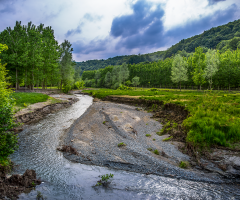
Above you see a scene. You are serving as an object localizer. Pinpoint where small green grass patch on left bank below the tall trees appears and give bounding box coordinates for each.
[12,92,49,107]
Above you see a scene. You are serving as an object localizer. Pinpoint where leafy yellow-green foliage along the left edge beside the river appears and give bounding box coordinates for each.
[0,44,17,165]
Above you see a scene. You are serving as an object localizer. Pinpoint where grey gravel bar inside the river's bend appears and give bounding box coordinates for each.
[58,98,240,183]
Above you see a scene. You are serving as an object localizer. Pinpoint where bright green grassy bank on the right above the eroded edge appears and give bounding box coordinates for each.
[85,88,240,151]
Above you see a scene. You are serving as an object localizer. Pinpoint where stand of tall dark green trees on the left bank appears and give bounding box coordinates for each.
[0,21,79,89]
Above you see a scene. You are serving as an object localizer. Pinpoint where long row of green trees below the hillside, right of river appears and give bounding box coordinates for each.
[82,47,240,89]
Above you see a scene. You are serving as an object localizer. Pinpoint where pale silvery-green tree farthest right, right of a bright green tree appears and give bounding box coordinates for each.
[204,49,219,90]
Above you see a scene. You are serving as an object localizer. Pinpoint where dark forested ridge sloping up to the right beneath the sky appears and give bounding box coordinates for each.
[76,20,240,72]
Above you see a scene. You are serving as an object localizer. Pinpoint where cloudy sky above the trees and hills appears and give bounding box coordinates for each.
[0,0,240,61]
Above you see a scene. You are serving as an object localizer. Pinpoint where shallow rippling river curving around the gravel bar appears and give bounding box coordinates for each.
[11,95,240,200]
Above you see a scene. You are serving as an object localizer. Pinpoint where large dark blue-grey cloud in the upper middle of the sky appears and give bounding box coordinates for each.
[110,0,164,49]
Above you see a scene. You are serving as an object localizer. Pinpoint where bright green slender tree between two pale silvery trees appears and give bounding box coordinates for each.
[192,47,205,90]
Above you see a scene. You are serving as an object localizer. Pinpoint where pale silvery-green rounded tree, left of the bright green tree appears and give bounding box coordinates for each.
[171,54,188,91]
